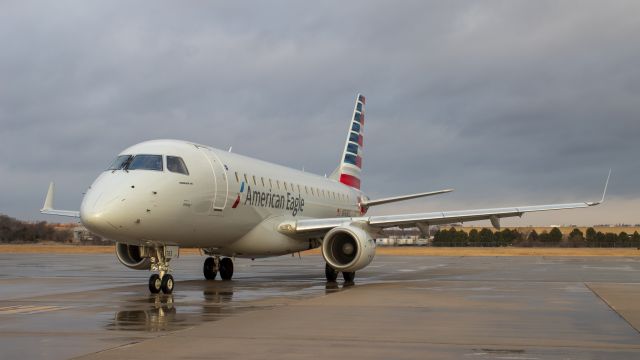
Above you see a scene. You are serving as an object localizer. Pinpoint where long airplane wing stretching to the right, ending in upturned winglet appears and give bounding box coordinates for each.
[278,171,611,234]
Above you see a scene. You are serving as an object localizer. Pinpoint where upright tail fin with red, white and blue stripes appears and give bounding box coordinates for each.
[331,94,365,189]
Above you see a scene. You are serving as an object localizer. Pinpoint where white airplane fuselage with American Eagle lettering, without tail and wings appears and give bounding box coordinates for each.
[80,140,364,257]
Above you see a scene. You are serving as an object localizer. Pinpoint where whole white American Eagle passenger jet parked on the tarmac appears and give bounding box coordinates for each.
[40,94,611,294]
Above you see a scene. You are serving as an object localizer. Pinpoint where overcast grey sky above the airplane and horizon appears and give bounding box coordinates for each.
[0,0,640,225]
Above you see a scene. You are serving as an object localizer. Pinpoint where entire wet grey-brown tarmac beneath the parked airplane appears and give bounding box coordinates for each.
[0,254,640,359]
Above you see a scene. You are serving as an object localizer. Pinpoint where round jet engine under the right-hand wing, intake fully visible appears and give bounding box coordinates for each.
[322,225,376,272]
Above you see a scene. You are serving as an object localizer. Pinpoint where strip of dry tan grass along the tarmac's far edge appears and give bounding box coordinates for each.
[0,245,640,256]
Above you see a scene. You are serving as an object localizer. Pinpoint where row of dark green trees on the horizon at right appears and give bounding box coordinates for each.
[432,227,640,248]
